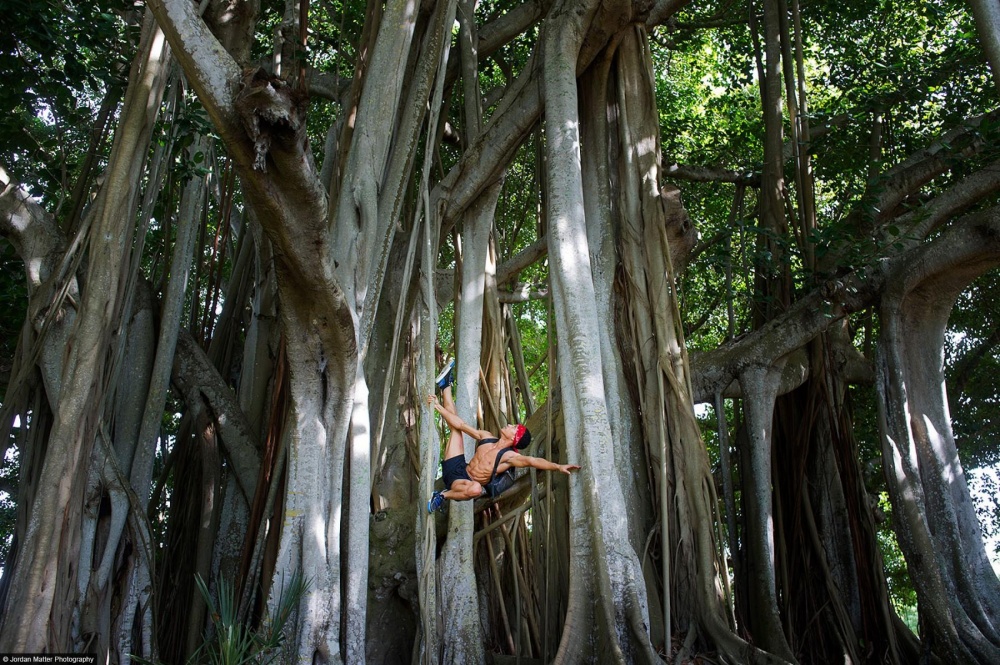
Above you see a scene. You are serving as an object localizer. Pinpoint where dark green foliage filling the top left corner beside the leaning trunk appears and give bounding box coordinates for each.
[0,0,135,203]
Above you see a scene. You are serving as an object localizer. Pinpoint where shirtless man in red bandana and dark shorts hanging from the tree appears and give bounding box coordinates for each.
[427,360,580,513]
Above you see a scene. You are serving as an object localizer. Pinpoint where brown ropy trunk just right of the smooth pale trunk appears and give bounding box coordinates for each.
[617,22,796,662]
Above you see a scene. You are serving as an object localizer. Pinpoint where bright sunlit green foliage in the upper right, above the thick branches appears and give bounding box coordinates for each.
[653,0,996,349]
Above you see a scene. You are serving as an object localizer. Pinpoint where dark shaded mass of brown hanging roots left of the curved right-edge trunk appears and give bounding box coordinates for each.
[773,324,917,663]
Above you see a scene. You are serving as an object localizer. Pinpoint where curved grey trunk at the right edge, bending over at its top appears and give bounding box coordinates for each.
[878,208,1000,664]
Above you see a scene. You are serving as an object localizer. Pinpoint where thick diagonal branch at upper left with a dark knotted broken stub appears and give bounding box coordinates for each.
[149,0,355,358]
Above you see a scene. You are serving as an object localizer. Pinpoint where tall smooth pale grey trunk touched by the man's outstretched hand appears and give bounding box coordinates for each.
[543,3,656,662]
